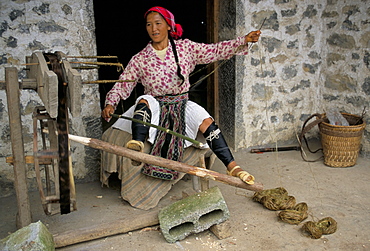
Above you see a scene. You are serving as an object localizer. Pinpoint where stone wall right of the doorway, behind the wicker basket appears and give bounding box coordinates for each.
[220,0,370,155]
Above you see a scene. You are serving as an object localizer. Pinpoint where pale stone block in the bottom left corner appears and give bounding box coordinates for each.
[0,221,55,251]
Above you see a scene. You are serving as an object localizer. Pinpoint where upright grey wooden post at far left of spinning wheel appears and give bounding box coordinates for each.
[5,67,32,228]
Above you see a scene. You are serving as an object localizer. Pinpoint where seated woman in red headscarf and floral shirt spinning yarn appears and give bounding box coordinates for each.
[102,7,261,184]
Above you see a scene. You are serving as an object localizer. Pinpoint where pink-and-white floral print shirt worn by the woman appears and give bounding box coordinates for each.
[105,37,248,108]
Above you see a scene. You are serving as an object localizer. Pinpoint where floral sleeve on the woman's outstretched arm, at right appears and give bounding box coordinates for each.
[191,36,248,64]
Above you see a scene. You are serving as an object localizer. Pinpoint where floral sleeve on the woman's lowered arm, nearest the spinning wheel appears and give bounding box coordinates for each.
[105,57,140,109]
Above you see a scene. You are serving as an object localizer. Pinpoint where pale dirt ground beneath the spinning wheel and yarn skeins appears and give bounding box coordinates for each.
[0,141,370,251]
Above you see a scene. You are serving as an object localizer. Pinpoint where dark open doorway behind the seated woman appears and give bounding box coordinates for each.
[94,0,214,130]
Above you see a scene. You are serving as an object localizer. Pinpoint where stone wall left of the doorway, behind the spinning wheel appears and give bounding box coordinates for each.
[0,0,101,197]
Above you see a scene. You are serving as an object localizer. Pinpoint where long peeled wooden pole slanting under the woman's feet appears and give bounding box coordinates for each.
[69,134,263,191]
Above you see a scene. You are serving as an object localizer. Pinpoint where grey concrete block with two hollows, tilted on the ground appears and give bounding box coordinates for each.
[158,187,230,243]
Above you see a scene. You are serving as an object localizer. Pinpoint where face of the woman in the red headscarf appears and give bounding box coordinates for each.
[146,12,171,43]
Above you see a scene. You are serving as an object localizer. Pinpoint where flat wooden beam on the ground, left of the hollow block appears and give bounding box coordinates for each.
[54,211,159,248]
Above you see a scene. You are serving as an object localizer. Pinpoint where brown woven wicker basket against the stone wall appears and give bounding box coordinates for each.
[319,113,366,167]
